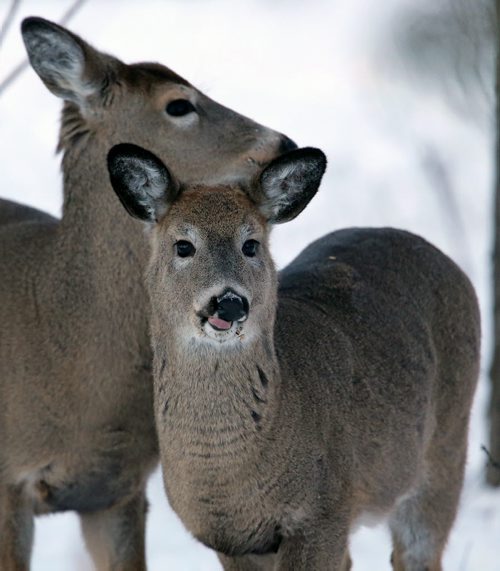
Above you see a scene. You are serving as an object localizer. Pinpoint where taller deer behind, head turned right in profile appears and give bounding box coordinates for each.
[0,17,296,571]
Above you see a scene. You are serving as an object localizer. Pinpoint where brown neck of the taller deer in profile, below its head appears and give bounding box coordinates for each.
[37,125,151,360]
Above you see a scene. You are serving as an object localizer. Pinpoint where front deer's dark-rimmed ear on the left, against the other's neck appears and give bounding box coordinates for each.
[108,143,179,222]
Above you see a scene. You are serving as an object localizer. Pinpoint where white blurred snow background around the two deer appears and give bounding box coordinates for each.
[0,0,500,571]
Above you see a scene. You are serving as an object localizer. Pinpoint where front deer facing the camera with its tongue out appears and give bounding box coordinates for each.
[108,144,480,571]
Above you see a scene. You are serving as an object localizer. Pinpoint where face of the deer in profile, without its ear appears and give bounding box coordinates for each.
[100,71,296,185]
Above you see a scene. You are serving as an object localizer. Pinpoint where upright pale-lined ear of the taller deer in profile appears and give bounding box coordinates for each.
[21,17,123,109]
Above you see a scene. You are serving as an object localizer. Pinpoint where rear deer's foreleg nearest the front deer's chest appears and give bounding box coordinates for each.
[80,491,147,571]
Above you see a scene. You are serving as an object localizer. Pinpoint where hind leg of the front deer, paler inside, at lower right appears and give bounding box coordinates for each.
[389,428,467,571]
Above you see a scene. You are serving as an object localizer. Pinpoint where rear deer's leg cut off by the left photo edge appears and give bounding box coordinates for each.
[0,486,33,571]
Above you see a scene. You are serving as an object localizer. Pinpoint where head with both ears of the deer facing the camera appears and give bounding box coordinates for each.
[108,145,326,347]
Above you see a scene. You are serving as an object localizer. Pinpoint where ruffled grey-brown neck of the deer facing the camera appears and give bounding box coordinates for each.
[153,326,281,471]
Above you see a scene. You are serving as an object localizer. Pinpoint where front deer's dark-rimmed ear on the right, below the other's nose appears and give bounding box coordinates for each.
[260,147,326,224]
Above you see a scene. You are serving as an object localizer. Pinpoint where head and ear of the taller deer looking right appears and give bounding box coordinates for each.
[22,18,296,184]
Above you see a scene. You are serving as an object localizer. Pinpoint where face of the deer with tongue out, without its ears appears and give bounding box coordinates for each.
[149,188,276,344]
